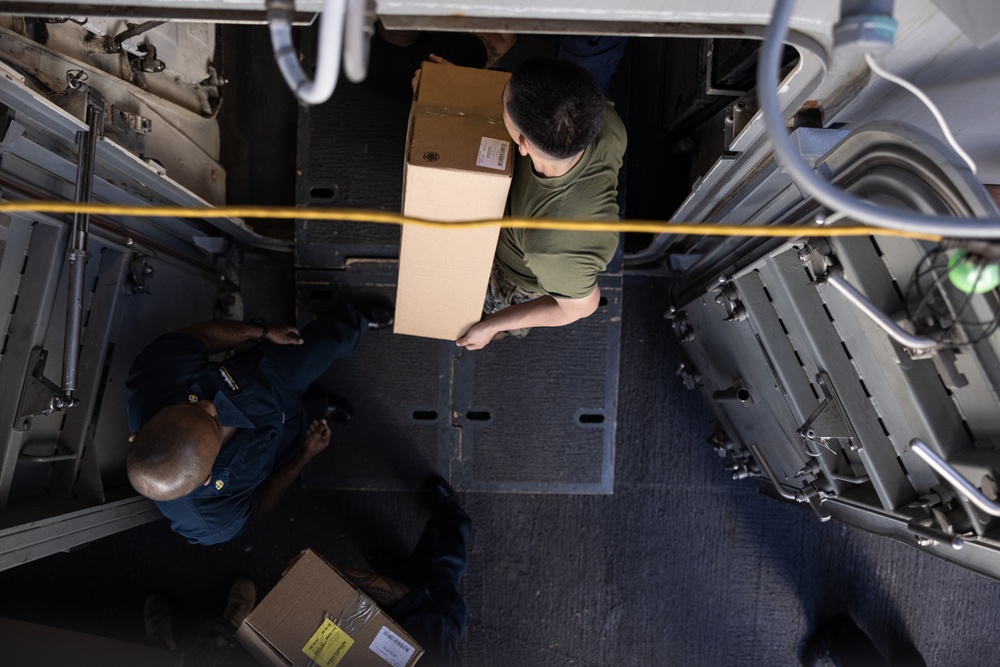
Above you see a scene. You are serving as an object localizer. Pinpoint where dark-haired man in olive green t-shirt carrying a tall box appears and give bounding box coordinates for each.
[456,58,626,350]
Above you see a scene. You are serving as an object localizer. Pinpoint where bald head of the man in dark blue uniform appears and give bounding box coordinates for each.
[126,400,222,500]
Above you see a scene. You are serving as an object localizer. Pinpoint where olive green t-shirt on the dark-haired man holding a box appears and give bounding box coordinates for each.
[496,101,626,299]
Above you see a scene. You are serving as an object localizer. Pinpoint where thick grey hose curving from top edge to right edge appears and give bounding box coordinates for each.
[757,0,1000,239]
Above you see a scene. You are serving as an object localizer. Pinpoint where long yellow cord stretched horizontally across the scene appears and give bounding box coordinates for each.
[0,201,942,242]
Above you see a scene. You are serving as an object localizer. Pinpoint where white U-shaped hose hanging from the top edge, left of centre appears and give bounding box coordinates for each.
[267,0,344,104]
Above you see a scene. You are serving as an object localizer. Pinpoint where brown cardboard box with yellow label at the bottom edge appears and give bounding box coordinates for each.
[236,549,424,667]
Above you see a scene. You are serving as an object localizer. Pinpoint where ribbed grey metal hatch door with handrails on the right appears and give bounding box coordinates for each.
[668,122,1000,578]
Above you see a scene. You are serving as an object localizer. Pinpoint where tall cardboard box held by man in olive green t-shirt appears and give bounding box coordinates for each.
[395,63,514,340]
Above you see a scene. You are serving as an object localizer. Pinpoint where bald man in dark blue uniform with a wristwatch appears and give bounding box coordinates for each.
[126,303,392,544]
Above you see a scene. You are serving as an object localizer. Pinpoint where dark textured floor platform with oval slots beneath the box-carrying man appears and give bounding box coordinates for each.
[295,77,622,493]
